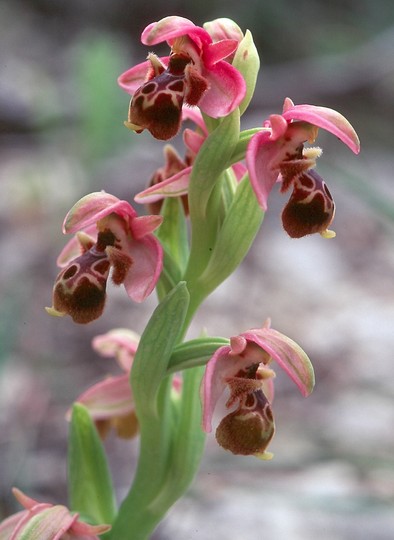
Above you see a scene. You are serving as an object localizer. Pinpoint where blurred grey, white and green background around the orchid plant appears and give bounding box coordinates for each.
[0,0,394,540]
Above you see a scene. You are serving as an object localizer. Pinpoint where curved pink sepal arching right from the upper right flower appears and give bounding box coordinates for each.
[283,105,360,154]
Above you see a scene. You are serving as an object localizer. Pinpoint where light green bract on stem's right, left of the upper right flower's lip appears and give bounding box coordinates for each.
[199,176,264,294]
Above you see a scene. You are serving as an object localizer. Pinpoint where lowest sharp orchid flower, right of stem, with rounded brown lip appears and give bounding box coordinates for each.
[201,321,314,459]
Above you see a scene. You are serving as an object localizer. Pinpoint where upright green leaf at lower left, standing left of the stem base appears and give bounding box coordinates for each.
[68,403,116,524]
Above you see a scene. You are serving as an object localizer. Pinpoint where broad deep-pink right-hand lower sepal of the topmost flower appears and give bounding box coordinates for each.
[198,61,246,118]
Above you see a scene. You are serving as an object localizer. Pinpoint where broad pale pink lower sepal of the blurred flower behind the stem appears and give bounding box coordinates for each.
[73,373,134,420]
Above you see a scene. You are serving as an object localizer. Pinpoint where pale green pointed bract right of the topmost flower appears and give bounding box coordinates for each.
[232,30,260,114]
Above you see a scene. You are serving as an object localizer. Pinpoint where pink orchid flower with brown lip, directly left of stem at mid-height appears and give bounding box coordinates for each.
[47,192,163,323]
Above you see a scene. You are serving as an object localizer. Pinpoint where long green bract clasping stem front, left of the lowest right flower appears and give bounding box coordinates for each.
[131,282,189,422]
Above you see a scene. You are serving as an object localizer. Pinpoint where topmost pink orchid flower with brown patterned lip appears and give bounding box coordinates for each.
[118,16,246,140]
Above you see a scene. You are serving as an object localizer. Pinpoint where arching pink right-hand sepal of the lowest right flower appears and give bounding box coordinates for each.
[242,328,315,396]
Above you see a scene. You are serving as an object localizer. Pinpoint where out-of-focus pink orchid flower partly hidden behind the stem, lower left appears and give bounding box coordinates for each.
[67,328,139,438]
